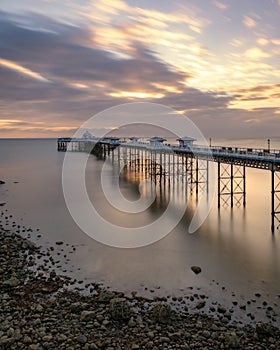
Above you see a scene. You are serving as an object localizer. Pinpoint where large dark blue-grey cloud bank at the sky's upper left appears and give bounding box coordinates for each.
[0,11,189,98]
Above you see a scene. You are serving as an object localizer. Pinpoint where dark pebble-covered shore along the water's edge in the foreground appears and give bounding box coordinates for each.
[0,212,280,350]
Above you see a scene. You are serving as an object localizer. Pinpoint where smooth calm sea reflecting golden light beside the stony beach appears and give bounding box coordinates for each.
[0,139,280,323]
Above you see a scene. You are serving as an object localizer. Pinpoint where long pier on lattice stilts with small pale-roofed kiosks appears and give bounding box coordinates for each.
[57,137,280,233]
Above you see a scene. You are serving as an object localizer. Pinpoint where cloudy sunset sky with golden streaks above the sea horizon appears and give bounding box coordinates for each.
[0,0,280,138]
